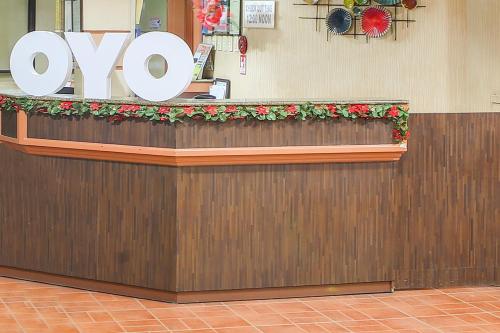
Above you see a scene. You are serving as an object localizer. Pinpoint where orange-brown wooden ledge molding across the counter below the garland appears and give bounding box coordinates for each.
[0,112,407,167]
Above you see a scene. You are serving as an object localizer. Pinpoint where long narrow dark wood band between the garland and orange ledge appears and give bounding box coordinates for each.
[28,115,392,148]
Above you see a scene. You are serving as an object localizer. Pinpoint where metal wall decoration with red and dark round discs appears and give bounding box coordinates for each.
[294,0,425,41]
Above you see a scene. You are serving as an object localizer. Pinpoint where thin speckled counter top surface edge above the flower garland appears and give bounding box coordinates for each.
[0,90,408,106]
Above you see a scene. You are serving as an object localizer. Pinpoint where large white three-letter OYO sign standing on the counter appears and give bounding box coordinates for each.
[10,31,194,102]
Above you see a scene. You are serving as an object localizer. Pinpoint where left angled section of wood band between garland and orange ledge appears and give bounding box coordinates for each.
[28,114,175,148]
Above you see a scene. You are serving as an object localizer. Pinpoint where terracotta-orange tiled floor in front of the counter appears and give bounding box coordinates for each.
[0,278,500,333]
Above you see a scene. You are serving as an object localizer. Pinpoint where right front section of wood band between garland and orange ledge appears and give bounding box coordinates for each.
[176,120,392,148]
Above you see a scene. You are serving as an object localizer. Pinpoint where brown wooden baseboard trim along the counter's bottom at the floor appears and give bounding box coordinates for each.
[0,266,394,303]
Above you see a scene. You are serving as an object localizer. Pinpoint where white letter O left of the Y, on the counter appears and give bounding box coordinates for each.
[10,31,73,96]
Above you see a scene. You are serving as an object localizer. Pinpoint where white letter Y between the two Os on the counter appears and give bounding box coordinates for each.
[64,32,130,99]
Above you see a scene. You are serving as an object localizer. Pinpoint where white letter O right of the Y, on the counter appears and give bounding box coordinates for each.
[123,32,194,102]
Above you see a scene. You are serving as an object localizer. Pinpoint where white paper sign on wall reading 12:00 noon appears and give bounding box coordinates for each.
[243,0,276,29]
